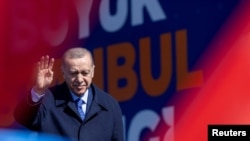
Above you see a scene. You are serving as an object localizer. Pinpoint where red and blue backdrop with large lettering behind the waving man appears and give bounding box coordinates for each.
[0,0,250,141]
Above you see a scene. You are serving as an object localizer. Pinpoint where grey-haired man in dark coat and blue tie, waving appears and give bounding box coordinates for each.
[14,47,124,141]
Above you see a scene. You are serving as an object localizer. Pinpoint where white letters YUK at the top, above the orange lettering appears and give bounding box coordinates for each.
[78,0,167,39]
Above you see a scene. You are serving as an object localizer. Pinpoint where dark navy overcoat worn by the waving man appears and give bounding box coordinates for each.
[14,83,124,141]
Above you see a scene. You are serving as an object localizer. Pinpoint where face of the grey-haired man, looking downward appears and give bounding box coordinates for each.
[62,56,94,96]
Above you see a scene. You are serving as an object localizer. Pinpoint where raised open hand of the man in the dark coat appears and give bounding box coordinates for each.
[34,55,55,94]
